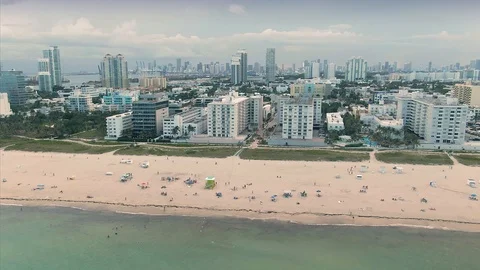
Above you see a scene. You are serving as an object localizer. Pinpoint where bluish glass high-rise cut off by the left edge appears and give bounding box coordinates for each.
[0,70,28,106]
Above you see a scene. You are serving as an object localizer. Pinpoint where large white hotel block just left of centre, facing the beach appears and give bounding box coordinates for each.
[207,92,263,138]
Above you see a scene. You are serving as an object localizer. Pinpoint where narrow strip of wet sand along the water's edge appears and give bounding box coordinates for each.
[0,197,480,233]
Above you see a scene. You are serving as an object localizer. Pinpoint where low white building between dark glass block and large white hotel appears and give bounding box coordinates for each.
[163,108,207,138]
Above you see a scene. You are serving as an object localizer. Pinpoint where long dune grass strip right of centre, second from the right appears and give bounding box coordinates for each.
[240,149,369,162]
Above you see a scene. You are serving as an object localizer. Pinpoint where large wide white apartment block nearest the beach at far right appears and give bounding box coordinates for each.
[397,93,468,144]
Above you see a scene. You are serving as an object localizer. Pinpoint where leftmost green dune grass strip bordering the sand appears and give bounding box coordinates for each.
[5,140,124,154]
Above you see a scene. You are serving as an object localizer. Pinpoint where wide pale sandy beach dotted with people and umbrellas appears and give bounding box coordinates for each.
[0,150,480,232]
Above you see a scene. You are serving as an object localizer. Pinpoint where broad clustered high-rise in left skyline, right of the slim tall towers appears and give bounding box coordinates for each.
[99,54,129,88]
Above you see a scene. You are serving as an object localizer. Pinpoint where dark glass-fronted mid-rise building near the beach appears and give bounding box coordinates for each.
[132,94,168,138]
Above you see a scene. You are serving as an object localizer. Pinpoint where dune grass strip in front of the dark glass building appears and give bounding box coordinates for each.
[115,146,239,158]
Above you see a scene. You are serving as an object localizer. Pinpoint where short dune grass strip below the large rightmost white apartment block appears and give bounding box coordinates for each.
[375,151,453,165]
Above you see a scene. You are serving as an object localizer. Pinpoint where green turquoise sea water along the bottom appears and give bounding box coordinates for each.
[0,206,480,270]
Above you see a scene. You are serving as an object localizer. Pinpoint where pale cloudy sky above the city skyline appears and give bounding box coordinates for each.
[0,0,480,73]
